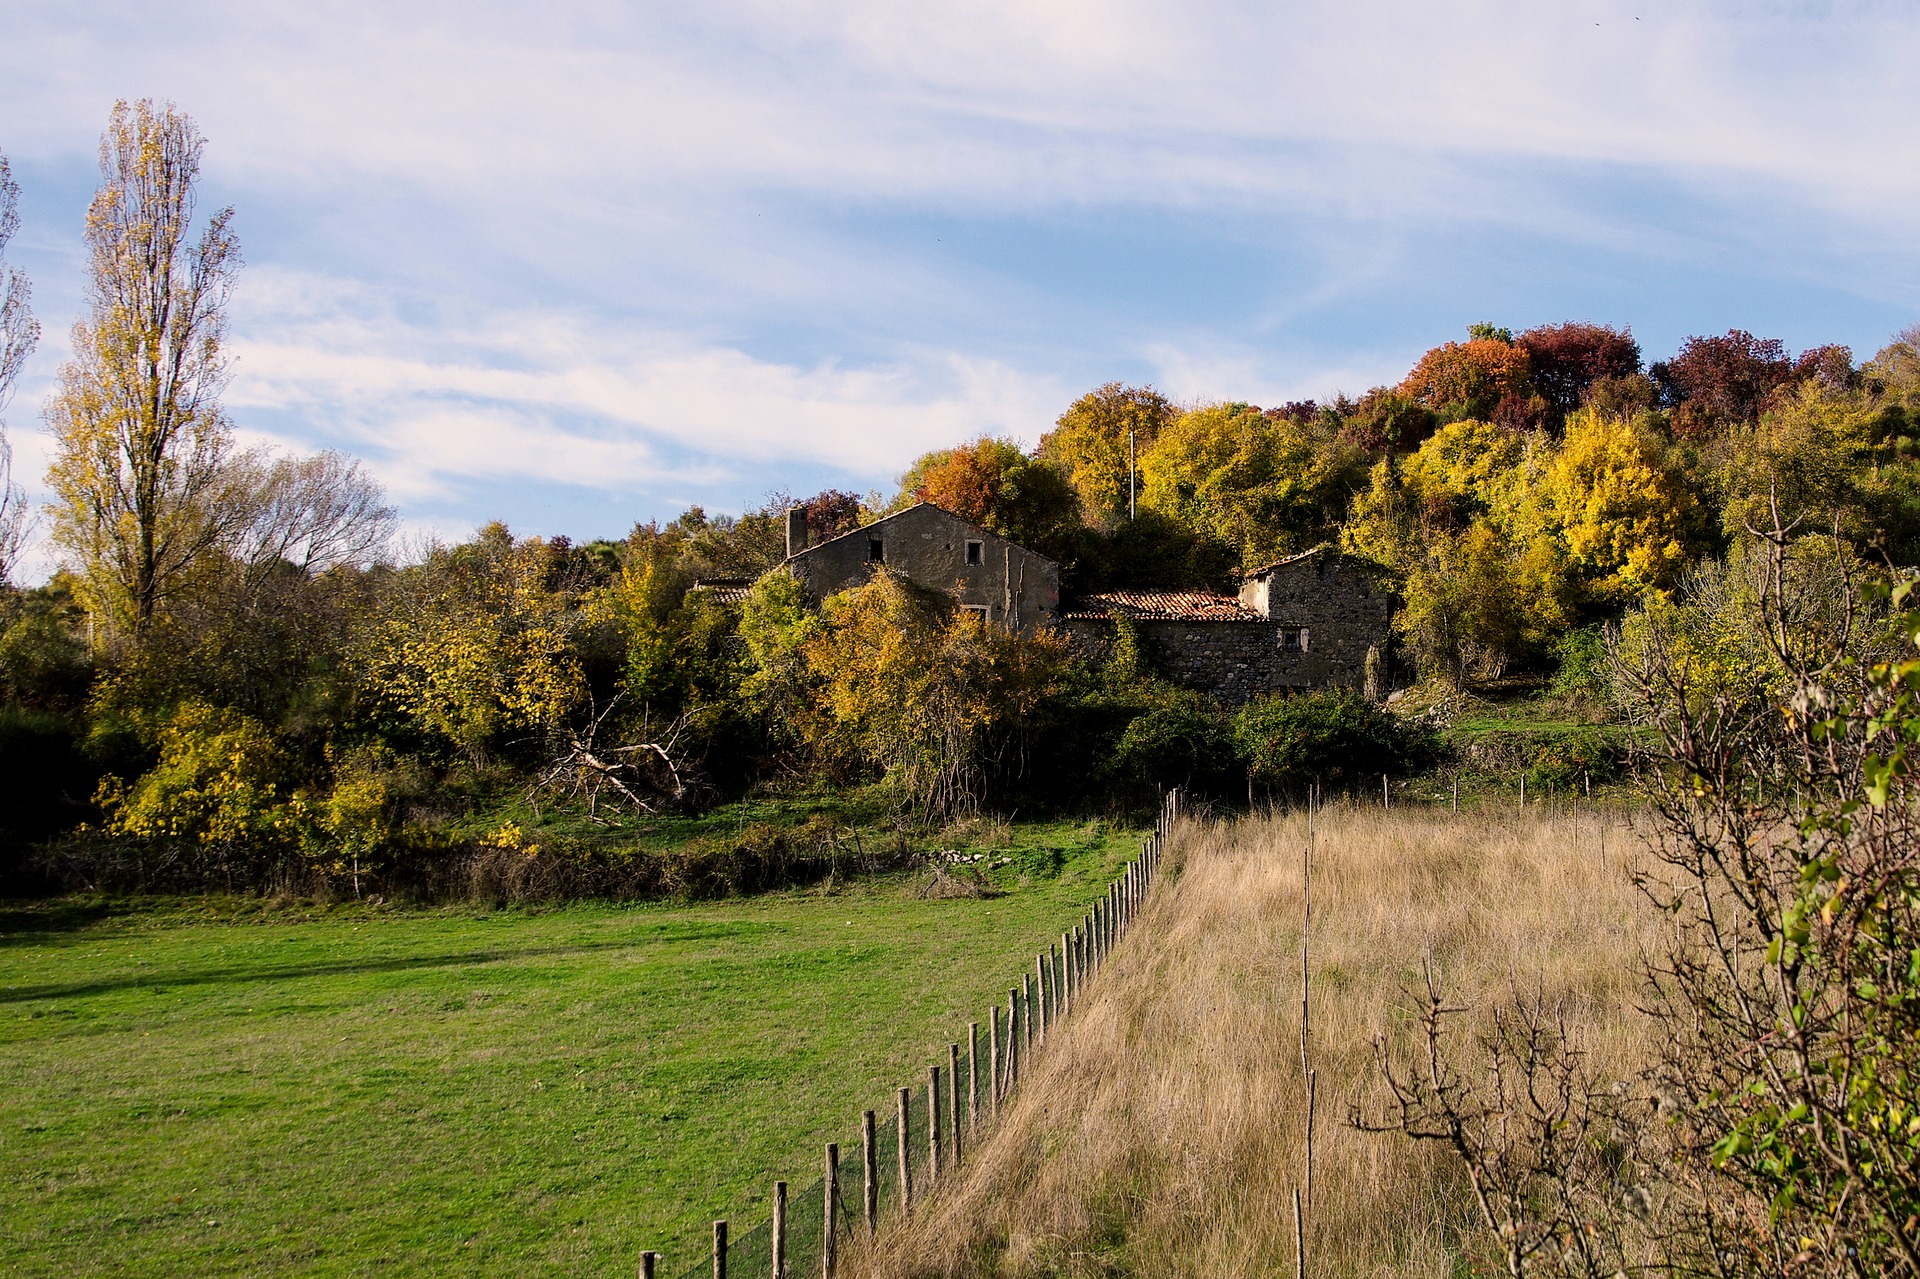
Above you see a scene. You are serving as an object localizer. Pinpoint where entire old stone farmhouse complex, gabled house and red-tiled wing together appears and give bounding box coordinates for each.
[708,501,1394,705]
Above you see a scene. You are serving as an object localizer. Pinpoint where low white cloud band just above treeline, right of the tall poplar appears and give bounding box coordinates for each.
[227,273,1062,499]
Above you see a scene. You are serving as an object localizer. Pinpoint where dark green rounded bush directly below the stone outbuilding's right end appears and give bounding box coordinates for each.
[1233,689,1436,787]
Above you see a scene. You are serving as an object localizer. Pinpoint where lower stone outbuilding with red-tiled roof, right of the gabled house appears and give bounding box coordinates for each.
[1060,545,1394,705]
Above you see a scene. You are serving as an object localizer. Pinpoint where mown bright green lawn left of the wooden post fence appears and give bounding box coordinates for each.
[0,824,1139,1275]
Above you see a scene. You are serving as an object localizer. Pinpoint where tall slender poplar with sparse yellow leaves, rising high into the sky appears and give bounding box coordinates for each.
[46,100,252,638]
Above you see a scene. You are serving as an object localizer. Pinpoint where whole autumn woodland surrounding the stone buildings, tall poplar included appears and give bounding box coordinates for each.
[0,102,1920,883]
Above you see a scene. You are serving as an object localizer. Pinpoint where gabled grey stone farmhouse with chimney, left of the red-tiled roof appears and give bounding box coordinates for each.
[785,501,1060,630]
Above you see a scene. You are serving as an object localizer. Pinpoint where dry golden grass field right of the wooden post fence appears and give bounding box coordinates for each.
[852,808,1655,1279]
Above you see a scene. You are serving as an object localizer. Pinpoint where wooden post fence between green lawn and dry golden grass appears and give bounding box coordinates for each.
[641,789,1181,1279]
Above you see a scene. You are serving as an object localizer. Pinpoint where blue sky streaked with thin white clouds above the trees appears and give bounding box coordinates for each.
[0,0,1920,572]
